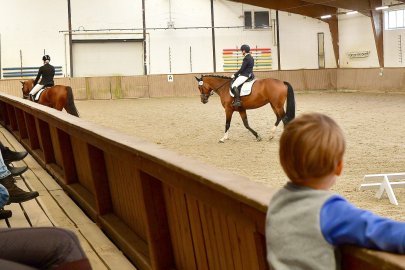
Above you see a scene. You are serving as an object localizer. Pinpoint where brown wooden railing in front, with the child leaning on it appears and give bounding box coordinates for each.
[0,94,405,270]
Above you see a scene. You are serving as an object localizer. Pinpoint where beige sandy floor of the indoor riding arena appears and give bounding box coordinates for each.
[77,92,405,221]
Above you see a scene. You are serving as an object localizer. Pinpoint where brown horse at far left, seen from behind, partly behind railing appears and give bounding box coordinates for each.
[21,79,79,117]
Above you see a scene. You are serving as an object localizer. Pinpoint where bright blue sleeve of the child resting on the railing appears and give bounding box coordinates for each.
[320,196,405,254]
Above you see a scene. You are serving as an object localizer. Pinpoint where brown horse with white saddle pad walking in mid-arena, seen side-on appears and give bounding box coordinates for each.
[195,75,295,143]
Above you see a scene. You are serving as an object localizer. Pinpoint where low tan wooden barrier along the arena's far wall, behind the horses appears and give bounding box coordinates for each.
[0,68,405,100]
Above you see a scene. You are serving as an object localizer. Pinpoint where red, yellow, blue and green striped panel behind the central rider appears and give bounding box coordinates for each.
[222,48,273,72]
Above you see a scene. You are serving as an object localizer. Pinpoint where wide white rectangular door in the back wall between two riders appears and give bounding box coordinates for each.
[72,40,143,77]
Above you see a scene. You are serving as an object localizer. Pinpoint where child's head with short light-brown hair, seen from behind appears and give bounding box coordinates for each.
[280,113,346,184]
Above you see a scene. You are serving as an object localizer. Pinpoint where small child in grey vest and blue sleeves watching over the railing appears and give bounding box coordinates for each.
[266,113,405,270]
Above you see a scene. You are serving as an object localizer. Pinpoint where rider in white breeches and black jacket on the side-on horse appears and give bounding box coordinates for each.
[232,44,255,107]
